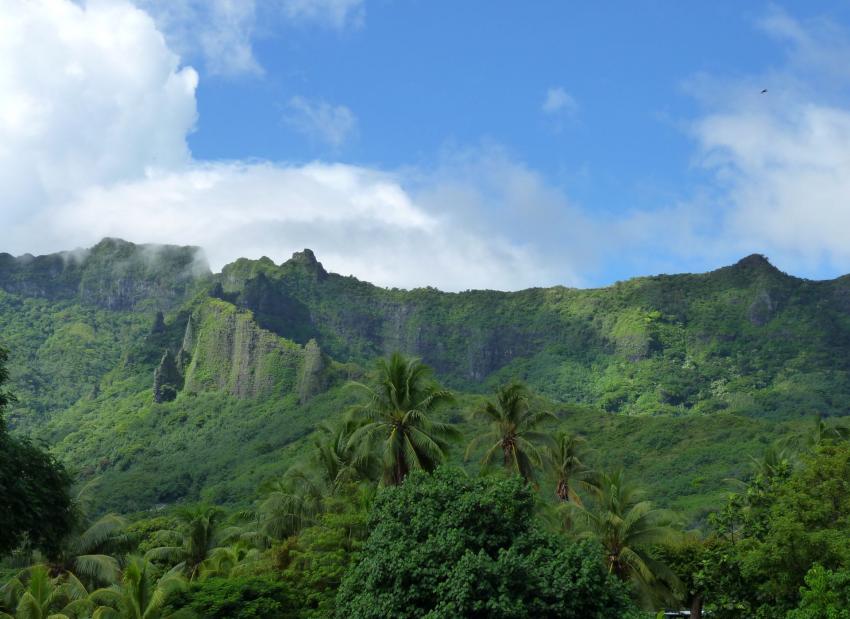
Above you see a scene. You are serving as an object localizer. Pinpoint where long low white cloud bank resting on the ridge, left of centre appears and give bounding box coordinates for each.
[32,163,539,289]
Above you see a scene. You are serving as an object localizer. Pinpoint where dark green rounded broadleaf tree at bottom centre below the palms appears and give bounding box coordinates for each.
[337,468,630,619]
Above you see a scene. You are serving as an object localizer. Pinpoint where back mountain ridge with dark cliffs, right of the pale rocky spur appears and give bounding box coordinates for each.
[217,251,850,418]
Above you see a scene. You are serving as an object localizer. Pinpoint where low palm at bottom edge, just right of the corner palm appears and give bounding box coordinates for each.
[89,556,186,619]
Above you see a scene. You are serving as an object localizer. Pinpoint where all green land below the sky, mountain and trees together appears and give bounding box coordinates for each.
[0,240,850,619]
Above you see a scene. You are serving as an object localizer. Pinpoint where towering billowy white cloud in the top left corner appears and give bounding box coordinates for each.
[0,0,197,220]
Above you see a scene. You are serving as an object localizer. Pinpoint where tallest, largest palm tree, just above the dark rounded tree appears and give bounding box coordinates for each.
[342,353,457,485]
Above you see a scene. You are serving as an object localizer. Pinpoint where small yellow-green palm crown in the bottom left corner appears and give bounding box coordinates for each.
[0,565,89,619]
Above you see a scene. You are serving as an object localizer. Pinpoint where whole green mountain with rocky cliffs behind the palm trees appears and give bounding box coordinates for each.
[0,239,850,515]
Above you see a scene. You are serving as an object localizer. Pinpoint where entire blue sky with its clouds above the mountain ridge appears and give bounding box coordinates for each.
[0,0,850,289]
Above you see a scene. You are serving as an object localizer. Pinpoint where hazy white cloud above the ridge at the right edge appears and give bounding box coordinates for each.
[690,11,850,273]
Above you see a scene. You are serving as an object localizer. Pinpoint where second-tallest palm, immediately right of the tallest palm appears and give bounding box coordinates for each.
[466,382,555,481]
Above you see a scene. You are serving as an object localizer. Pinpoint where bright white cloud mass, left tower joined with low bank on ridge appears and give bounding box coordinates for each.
[0,0,538,288]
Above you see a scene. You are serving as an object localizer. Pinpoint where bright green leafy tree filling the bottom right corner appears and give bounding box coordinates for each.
[684,440,850,618]
